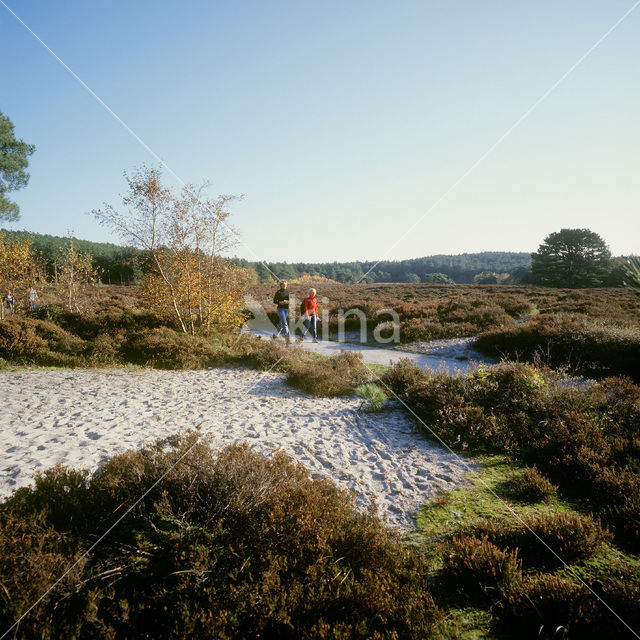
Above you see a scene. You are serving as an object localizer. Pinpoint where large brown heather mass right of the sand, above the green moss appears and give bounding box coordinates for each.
[386,363,640,549]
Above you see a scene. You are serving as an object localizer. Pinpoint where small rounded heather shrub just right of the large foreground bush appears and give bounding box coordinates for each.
[442,536,522,598]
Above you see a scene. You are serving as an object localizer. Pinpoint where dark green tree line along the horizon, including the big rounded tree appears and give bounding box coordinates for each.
[2,230,627,287]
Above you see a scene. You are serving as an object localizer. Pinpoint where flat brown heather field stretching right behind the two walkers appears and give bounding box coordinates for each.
[251,284,640,342]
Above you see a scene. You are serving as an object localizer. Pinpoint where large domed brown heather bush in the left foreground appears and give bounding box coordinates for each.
[0,434,441,639]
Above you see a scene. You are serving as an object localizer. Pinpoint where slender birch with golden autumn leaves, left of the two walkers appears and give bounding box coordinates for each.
[93,167,246,333]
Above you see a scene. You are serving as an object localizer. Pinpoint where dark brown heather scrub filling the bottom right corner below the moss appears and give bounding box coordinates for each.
[440,516,640,640]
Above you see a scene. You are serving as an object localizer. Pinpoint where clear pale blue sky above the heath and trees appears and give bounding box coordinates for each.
[0,0,640,262]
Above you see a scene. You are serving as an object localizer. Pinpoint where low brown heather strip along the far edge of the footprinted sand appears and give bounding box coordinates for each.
[0,308,374,395]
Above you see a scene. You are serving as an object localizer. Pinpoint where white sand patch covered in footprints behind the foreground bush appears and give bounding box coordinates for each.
[0,368,465,529]
